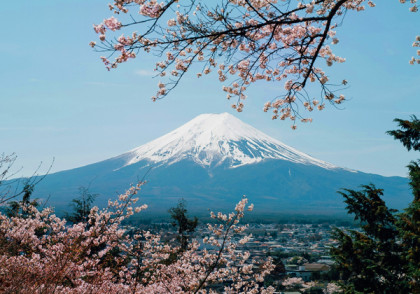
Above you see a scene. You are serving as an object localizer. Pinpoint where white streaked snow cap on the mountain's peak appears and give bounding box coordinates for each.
[119,113,338,169]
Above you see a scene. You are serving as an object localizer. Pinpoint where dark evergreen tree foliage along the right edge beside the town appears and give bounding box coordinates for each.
[331,116,420,294]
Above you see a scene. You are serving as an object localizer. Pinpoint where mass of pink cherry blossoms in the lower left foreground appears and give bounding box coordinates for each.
[0,183,274,294]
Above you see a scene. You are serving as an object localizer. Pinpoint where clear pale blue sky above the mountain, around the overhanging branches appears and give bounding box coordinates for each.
[0,0,420,176]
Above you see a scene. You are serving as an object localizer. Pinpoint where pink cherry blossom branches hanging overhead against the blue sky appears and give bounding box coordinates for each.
[91,0,417,127]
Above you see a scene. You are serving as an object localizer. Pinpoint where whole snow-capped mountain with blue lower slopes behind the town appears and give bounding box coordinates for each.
[35,113,410,214]
